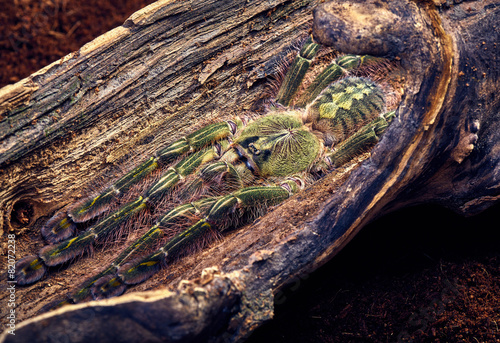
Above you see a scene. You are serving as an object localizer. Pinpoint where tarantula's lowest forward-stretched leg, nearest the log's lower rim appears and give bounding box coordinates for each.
[93,183,303,295]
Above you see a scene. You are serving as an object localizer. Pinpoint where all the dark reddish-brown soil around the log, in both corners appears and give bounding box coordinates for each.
[0,0,500,342]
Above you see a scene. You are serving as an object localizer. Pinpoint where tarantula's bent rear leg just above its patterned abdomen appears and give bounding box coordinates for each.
[297,55,380,107]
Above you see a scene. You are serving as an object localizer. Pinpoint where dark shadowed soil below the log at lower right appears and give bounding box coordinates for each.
[249,205,500,343]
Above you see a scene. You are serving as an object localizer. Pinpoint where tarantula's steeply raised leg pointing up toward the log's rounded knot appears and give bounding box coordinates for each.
[276,37,320,106]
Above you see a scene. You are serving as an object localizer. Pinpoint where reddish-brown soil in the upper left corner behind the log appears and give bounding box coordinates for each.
[0,0,154,87]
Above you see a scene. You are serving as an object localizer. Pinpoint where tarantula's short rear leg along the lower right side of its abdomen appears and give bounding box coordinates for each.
[326,111,395,167]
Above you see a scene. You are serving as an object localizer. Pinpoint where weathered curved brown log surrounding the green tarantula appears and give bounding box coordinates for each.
[0,0,500,342]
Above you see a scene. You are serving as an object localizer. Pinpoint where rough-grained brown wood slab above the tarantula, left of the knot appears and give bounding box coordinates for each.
[0,1,318,235]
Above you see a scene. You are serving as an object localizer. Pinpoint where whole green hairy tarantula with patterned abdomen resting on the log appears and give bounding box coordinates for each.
[16,38,400,310]
